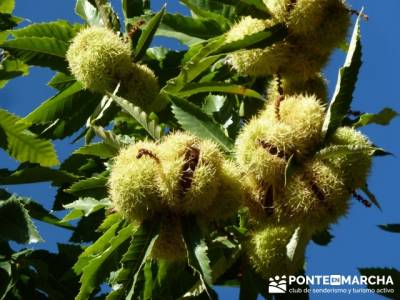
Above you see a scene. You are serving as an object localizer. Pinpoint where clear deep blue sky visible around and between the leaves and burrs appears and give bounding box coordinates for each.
[0,0,400,300]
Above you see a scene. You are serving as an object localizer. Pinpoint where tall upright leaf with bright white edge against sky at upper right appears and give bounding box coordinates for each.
[322,12,362,136]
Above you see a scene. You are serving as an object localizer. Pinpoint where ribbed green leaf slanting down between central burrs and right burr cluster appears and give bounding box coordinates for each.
[170,96,233,152]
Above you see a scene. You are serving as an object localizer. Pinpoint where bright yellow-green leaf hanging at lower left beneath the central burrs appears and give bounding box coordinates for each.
[74,224,132,300]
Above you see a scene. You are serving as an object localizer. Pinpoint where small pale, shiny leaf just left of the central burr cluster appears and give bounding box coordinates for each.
[62,197,110,222]
